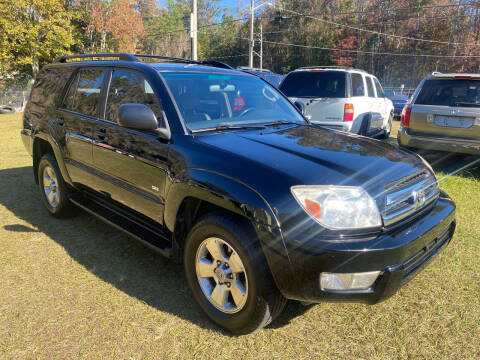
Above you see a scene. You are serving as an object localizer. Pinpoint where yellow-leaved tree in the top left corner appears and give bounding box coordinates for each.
[0,0,74,76]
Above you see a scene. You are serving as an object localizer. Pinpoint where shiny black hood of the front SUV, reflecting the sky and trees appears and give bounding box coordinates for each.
[191,125,425,198]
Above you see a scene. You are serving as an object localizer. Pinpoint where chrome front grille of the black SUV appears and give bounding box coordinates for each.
[382,170,439,226]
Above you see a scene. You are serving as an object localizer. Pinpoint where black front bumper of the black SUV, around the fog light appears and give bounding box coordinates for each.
[264,193,455,304]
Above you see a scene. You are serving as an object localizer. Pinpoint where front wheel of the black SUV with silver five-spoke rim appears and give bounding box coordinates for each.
[184,213,286,334]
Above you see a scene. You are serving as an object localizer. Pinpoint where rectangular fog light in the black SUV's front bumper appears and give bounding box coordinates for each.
[320,271,380,290]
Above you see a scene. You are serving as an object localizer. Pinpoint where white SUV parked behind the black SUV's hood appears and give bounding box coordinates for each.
[280,66,393,137]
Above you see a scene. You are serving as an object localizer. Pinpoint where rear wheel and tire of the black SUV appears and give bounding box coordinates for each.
[38,153,73,217]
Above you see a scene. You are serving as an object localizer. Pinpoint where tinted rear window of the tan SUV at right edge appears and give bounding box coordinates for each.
[415,79,480,107]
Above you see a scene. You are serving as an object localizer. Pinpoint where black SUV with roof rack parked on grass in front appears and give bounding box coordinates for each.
[22,54,455,334]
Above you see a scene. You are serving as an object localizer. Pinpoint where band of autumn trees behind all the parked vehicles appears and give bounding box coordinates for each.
[0,0,480,87]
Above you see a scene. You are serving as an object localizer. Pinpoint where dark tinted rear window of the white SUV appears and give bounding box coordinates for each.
[280,71,346,98]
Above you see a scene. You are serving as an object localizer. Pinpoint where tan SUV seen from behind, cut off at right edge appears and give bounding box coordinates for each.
[398,73,480,155]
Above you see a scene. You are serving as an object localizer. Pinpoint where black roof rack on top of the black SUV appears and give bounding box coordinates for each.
[54,53,233,69]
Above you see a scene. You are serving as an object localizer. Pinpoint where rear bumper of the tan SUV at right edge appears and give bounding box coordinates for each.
[397,127,480,155]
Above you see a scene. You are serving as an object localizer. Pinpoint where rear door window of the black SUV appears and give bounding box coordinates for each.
[64,69,105,117]
